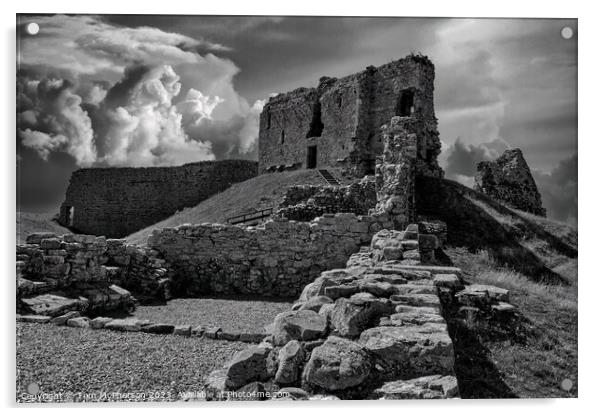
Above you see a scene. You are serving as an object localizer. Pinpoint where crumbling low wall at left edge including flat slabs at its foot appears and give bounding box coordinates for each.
[16,233,169,316]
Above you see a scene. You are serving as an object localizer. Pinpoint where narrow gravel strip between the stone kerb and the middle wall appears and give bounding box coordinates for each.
[134,298,292,333]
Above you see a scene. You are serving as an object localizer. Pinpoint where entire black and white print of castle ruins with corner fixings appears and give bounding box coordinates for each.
[7,8,580,406]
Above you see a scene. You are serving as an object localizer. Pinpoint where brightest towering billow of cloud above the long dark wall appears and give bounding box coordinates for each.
[95,65,214,166]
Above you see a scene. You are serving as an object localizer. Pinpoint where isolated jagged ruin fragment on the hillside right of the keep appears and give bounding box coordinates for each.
[474,149,546,217]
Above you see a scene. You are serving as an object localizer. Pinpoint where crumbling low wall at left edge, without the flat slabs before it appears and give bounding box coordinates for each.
[17,233,169,300]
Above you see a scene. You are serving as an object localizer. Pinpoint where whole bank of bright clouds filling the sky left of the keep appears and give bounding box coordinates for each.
[17,15,263,166]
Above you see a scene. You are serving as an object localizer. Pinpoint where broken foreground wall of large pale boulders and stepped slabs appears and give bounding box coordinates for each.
[205,225,463,399]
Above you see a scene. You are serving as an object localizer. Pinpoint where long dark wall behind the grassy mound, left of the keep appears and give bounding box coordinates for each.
[59,160,257,237]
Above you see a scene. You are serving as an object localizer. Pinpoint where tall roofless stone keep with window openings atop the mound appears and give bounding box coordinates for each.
[259,55,443,178]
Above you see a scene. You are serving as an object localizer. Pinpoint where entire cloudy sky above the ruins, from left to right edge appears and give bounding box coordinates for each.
[17,15,577,223]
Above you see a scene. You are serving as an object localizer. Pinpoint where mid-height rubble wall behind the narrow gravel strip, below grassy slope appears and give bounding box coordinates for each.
[148,214,381,297]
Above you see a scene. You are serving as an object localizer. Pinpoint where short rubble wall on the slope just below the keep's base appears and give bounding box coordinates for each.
[275,176,376,221]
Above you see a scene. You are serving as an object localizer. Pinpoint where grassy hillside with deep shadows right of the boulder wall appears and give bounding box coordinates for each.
[417,179,578,398]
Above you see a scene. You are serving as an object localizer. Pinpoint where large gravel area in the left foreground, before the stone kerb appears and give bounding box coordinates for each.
[17,322,248,402]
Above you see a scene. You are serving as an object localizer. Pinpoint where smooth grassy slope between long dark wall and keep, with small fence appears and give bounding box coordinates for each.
[126,170,345,244]
